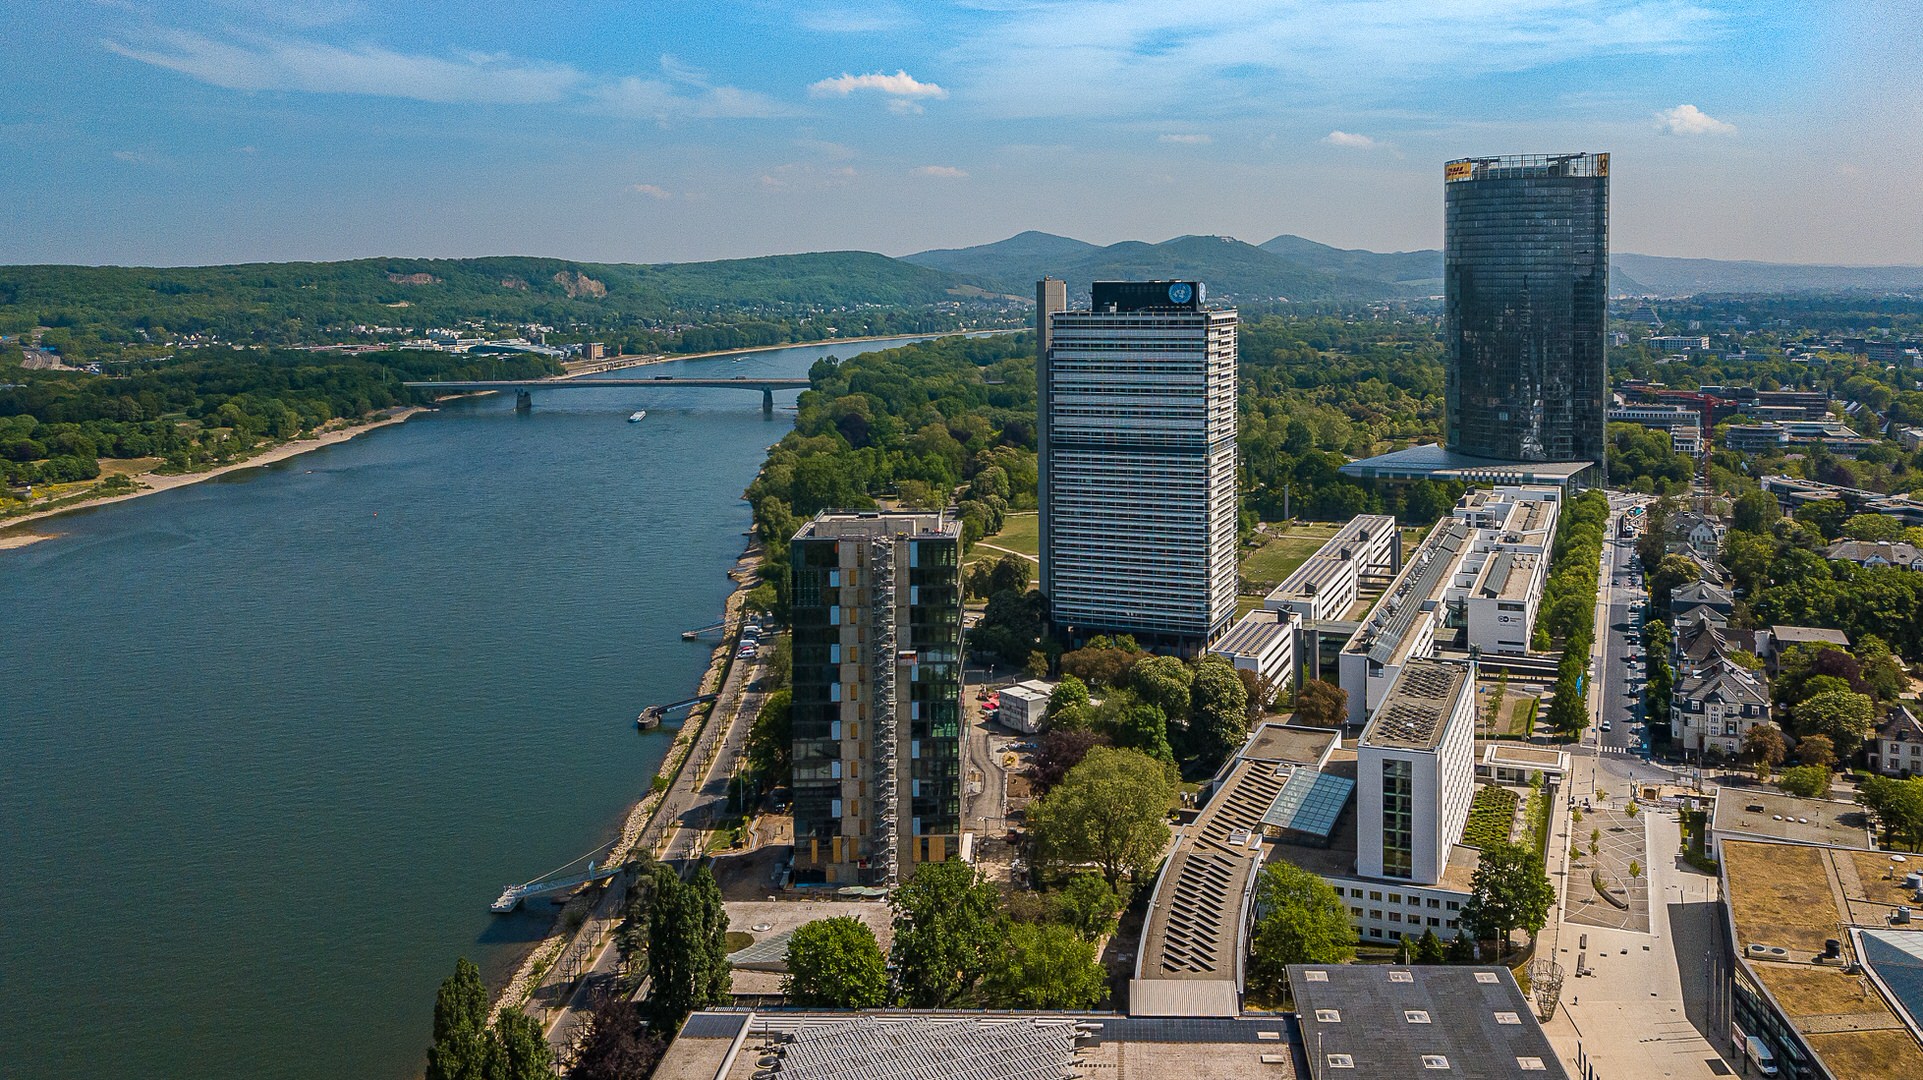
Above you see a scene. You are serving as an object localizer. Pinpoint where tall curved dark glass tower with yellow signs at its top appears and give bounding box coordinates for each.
[1442,154,1610,475]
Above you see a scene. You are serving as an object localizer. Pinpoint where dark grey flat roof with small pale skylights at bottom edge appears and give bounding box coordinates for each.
[1288,965,1569,1080]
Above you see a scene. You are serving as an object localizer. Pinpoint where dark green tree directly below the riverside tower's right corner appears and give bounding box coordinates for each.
[888,859,1006,1009]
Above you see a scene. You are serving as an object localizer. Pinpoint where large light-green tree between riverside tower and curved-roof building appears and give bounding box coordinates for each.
[1029,746,1177,888]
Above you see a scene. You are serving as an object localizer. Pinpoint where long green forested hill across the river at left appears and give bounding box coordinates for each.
[0,252,1010,359]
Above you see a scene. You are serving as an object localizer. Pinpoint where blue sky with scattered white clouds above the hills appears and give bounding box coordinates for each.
[0,0,1923,265]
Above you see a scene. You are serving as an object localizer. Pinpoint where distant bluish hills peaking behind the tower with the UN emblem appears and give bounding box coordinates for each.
[902,233,1398,302]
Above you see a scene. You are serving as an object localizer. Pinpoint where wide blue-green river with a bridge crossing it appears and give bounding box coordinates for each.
[0,338,930,1080]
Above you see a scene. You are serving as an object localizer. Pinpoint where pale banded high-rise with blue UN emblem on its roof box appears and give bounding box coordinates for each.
[1036,281,1236,648]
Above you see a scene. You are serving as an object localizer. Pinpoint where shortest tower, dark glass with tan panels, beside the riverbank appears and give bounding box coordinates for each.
[788,513,963,886]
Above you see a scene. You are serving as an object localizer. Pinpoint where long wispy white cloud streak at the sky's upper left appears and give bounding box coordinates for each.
[102,31,587,104]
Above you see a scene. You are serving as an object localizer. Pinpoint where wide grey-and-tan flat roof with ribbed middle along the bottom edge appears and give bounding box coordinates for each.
[654,1009,1306,1080]
